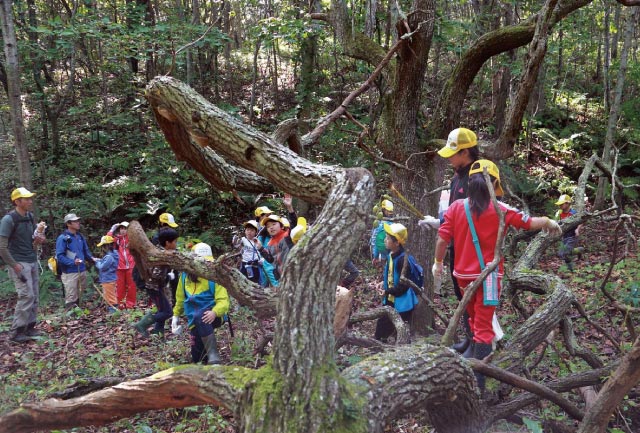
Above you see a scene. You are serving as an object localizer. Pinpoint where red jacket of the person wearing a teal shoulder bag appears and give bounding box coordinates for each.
[438,199,531,280]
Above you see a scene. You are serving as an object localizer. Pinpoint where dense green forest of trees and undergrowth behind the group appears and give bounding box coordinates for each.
[0,0,640,431]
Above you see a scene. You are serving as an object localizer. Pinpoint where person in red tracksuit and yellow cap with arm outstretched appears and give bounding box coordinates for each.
[432,159,562,389]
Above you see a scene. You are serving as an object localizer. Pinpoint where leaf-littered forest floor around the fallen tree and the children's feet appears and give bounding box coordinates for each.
[0,218,640,433]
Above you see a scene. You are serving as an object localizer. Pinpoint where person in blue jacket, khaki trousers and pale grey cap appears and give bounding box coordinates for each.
[56,213,96,310]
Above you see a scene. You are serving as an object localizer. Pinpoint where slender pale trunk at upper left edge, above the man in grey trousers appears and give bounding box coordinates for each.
[0,0,33,189]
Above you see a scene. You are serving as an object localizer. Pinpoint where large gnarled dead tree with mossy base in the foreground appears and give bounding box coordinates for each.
[0,77,640,433]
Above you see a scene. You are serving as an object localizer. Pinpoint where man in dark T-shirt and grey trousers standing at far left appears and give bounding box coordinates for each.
[0,187,46,343]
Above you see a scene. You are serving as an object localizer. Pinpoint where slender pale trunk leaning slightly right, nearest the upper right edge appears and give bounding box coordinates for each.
[593,8,640,209]
